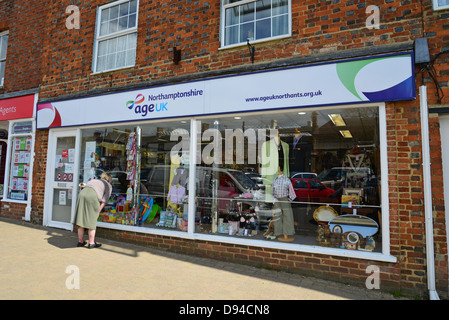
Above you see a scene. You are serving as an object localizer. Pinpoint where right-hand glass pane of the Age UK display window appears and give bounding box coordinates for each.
[195,107,382,252]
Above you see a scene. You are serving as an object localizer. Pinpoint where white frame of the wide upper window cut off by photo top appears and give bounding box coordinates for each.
[220,0,292,49]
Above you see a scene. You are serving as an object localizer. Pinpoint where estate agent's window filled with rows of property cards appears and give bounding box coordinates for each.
[6,121,33,201]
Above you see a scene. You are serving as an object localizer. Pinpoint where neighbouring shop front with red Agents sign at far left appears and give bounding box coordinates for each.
[0,93,38,220]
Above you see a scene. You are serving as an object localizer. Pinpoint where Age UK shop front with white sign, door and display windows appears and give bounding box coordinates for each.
[37,52,415,262]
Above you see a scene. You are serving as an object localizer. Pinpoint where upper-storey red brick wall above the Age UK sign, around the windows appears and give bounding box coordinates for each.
[41,0,448,98]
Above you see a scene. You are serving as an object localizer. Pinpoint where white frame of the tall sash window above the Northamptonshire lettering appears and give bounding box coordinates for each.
[92,0,139,74]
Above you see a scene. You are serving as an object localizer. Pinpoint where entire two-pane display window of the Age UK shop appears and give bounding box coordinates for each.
[80,106,382,252]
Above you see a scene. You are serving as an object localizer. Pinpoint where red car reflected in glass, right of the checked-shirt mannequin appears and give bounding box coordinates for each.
[291,179,335,202]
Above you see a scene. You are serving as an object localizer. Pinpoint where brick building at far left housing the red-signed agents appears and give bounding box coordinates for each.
[0,1,45,220]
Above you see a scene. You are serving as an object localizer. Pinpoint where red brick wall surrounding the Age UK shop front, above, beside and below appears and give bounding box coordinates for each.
[23,0,449,295]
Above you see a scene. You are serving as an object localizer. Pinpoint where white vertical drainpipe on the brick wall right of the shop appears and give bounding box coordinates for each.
[419,85,440,300]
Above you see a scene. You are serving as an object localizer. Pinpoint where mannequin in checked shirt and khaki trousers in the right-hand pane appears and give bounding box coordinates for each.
[271,162,296,242]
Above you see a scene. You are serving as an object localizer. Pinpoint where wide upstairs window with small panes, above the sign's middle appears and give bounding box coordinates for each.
[222,0,290,46]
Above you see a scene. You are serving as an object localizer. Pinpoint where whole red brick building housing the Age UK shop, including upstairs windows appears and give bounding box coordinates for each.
[0,0,449,297]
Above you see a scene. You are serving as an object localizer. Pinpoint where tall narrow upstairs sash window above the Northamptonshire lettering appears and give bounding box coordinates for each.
[94,0,139,72]
